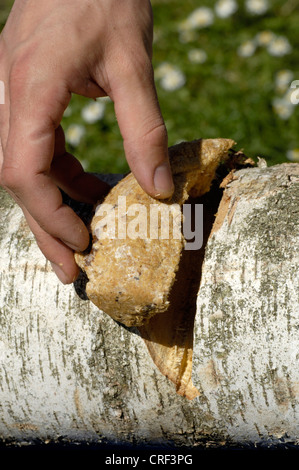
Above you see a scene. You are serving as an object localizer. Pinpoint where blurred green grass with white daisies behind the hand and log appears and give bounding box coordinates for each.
[0,0,299,173]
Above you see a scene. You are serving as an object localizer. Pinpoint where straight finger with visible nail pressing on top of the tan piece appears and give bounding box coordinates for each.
[111,59,174,199]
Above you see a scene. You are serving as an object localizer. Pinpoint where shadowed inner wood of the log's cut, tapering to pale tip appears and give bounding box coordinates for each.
[138,187,222,399]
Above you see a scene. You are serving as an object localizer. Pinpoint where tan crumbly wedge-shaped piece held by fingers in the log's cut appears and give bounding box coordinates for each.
[75,139,234,326]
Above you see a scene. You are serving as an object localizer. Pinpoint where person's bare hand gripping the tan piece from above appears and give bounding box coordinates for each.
[0,0,173,284]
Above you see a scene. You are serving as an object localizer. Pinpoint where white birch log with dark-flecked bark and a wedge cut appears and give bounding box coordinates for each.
[0,163,299,447]
